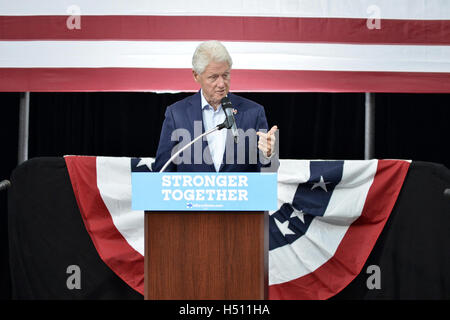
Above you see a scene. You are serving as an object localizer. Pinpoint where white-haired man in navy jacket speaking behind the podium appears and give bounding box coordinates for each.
[152,40,277,172]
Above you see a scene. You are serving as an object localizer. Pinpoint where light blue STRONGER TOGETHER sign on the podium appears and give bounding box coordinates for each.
[131,172,277,211]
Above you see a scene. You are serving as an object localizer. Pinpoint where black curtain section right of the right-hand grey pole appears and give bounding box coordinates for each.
[375,93,450,168]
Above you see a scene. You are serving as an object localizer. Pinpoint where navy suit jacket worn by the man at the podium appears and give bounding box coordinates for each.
[152,91,268,172]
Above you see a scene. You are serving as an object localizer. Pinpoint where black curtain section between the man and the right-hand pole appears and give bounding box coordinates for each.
[242,93,364,159]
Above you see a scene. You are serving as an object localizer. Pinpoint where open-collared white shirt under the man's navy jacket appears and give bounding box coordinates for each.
[200,90,227,172]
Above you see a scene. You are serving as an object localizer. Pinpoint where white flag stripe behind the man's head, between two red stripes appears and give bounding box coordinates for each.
[0,41,450,72]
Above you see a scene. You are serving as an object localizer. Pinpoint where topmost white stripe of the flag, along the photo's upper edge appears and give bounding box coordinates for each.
[0,0,450,20]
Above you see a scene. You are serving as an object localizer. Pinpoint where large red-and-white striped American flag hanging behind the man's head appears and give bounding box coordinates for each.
[0,0,450,92]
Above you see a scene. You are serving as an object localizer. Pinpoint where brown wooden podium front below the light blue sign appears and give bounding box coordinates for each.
[144,211,269,300]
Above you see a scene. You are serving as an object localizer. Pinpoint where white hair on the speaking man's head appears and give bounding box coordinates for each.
[192,40,233,74]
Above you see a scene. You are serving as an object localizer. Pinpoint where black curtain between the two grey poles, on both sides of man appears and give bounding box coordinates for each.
[30,93,364,159]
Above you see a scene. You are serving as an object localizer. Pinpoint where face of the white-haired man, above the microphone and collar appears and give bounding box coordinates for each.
[193,61,230,109]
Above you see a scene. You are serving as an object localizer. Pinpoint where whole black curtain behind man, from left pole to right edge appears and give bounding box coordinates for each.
[24,92,450,168]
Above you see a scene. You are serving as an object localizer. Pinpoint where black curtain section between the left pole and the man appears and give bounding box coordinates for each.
[29,92,188,158]
